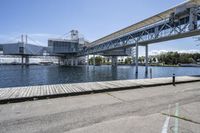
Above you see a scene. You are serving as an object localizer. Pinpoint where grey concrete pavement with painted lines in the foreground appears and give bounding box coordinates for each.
[0,80,200,133]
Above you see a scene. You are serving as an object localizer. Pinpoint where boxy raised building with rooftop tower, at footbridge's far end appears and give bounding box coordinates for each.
[48,30,88,66]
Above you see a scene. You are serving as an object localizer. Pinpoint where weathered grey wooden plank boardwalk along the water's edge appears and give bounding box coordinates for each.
[0,76,200,103]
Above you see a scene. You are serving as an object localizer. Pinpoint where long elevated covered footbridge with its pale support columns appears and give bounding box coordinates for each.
[79,0,200,73]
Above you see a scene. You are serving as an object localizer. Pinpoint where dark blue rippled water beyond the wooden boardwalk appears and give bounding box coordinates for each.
[0,65,200,88]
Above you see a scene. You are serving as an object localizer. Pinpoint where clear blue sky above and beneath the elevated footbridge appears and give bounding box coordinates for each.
[0,0,200,55]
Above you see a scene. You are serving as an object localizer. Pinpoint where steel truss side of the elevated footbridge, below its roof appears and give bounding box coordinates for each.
[79,7,200,56]
